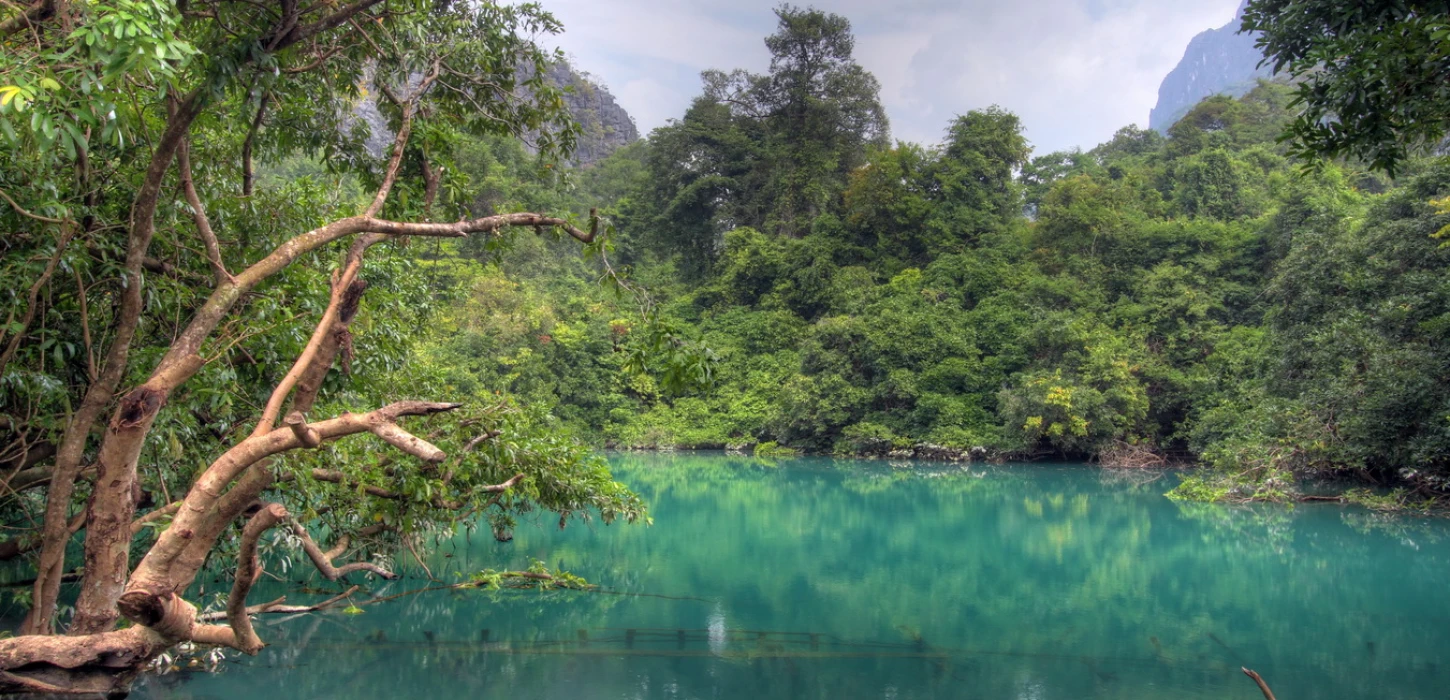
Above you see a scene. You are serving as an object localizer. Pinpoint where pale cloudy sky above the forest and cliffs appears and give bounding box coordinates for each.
[542,0,1240,155]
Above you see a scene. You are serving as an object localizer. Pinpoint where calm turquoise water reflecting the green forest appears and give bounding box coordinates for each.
[136,455,1450,700]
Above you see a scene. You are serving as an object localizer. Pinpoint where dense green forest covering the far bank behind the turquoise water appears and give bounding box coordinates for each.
[452,10,1450,507]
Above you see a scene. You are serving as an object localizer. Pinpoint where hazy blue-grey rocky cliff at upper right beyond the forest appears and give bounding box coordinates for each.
[1148,0,1272,132]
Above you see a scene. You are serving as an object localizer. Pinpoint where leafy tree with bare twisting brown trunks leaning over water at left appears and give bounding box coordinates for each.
[0,0,679,693]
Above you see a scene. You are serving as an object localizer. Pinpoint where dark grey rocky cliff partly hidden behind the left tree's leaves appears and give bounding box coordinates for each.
[352,61,639,165]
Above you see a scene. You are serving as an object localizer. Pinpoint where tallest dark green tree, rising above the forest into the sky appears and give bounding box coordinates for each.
[644,4,889,263]
